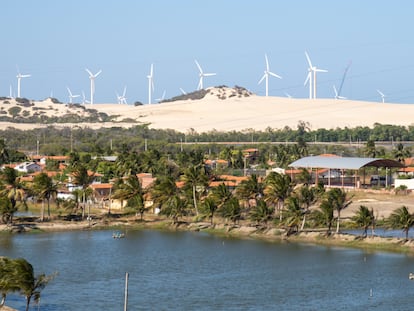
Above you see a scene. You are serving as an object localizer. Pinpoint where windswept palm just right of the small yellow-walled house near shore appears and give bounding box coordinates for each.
[112,175,146,220]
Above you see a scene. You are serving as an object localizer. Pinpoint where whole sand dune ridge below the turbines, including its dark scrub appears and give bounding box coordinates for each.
[0,86,414,133]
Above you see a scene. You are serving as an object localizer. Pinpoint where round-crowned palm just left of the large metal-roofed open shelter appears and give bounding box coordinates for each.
[263,172,294,221]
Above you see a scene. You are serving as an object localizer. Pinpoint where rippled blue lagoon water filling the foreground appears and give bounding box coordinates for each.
[0,230,414,311]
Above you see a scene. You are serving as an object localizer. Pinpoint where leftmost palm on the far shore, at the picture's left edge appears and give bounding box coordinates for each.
[0,167,26,223]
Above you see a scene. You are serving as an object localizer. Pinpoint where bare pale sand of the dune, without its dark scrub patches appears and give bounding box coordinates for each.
[0,88,414,132]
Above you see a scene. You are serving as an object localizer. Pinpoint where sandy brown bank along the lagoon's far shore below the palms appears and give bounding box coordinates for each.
[0,215,414,255]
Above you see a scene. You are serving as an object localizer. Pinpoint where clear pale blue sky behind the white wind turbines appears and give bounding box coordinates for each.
[0,0,414,103]
